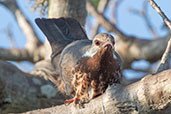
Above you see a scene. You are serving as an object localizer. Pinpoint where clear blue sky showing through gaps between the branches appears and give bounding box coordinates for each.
[0,0,171,79]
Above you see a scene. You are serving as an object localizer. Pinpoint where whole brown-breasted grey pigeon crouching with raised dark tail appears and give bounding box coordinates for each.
[35,17,122,105]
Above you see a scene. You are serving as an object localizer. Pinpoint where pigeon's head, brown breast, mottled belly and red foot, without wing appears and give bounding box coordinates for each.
[66,33,122,105]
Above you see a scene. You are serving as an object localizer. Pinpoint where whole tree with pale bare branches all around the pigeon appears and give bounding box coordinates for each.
[0,0,171,114]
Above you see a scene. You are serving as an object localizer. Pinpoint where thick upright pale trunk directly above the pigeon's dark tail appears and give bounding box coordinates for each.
[48,0,87,25]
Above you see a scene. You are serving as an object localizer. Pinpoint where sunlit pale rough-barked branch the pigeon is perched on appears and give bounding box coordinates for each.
[23,70,171,114]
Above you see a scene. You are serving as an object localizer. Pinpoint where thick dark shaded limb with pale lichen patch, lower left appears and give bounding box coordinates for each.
[0,61,66,114]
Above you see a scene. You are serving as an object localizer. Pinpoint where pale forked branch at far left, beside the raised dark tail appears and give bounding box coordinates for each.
[0,0,48,62]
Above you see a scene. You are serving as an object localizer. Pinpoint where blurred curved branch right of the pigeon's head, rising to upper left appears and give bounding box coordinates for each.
[87,0,170,68]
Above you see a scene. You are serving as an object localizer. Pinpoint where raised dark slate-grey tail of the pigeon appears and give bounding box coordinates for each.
[35,17,88,57]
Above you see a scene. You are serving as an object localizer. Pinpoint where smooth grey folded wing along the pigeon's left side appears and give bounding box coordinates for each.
[58,40,91,95]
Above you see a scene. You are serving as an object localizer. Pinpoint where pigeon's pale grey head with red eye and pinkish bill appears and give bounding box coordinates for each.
[83,33,115,57]
